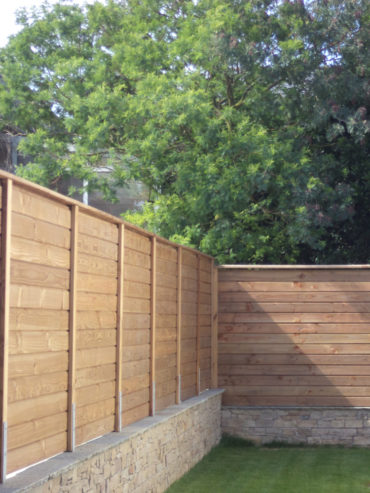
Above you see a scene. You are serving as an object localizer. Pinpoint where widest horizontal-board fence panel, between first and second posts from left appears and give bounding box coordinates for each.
[7,186,71,470]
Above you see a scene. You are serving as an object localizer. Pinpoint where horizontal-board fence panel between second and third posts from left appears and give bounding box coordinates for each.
[75,211,118,445]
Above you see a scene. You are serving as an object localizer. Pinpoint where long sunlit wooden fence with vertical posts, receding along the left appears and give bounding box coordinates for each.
[0,172,217,480]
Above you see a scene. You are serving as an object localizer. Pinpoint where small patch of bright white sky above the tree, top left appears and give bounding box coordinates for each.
[0,0,92,47]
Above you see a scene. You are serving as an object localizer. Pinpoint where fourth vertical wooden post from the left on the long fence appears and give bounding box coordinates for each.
[150,236,157,416]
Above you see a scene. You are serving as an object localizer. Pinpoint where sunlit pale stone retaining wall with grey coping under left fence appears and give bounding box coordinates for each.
[0,390,222,493]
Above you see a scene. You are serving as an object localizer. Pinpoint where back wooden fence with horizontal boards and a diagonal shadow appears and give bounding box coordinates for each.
[219,265,370,406]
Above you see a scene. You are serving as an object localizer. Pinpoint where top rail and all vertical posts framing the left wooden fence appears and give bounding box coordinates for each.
[0,171,217,482]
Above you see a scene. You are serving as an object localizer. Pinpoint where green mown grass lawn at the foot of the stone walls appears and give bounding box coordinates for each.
[166,437,370,493]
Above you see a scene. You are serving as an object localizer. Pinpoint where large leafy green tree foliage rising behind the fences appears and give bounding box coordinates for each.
[0,0,370,263]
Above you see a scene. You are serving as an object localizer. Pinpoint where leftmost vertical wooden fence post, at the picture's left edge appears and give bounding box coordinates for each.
[0,179,13,483]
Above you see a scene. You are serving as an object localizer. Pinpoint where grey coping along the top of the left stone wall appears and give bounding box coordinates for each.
[0,389,224,493]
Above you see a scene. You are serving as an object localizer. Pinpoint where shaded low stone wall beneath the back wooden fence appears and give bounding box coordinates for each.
[221,406,370,446]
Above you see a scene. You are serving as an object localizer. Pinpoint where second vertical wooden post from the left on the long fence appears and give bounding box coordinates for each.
[67,205,79,452]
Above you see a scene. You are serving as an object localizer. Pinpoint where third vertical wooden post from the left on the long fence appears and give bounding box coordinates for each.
[114,223,125,431]
